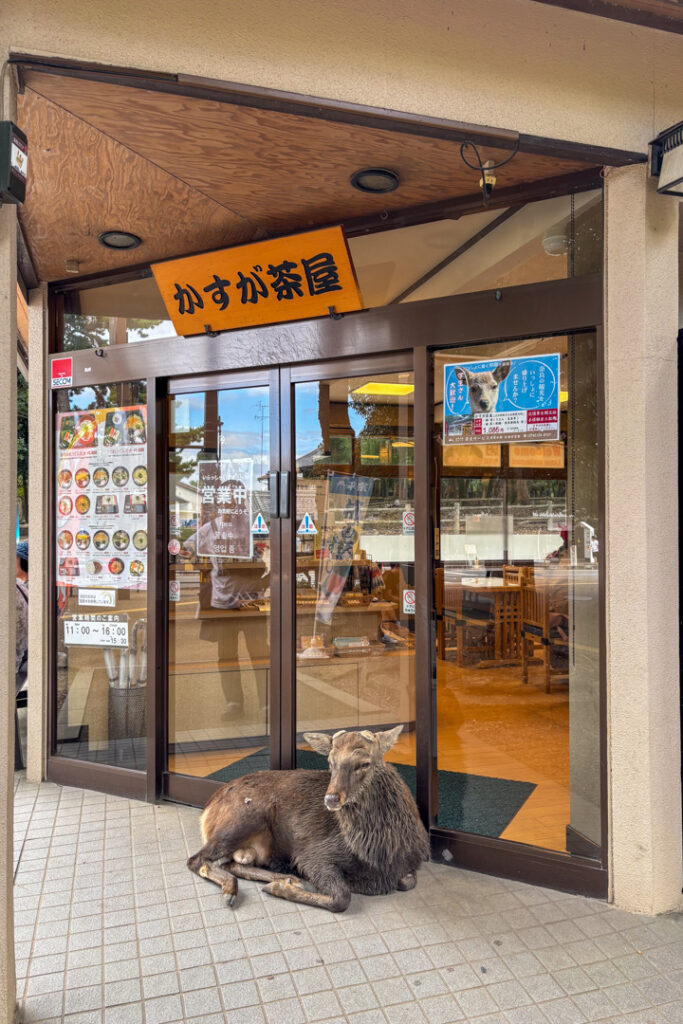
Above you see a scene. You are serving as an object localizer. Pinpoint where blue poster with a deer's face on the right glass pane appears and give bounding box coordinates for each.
[443,352,560,444]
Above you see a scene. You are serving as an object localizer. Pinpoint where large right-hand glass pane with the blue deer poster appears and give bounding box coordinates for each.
[432,334,602,858]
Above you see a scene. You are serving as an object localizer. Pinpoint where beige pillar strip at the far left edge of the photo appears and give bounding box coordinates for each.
[0,206,16,1022]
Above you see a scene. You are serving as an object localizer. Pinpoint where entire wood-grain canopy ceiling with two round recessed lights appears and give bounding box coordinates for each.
[17,67,633,281]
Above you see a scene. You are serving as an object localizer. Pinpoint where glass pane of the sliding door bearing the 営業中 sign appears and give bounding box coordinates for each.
[168,379,276,781]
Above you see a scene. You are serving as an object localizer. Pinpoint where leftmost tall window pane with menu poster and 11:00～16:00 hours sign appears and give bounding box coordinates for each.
[54,381,148,771]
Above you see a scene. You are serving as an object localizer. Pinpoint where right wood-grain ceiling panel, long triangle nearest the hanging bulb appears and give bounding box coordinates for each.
[26,71,587,233]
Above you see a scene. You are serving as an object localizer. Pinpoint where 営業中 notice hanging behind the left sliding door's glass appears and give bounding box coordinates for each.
[197,459,254,558]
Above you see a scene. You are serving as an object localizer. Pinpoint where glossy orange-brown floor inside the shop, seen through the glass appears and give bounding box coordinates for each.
[169,655,569,852]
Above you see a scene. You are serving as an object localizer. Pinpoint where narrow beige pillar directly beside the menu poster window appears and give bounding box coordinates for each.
[26,285,48,782]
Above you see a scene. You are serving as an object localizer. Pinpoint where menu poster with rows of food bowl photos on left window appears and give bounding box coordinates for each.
[56,406,147,590]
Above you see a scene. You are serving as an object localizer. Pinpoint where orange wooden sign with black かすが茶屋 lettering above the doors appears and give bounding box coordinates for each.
[152,227,362,335]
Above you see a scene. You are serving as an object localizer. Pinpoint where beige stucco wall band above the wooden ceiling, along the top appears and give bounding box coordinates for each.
[0,0,683,151]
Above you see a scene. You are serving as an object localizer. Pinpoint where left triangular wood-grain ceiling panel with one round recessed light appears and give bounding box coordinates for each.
[18,89,256,281]
